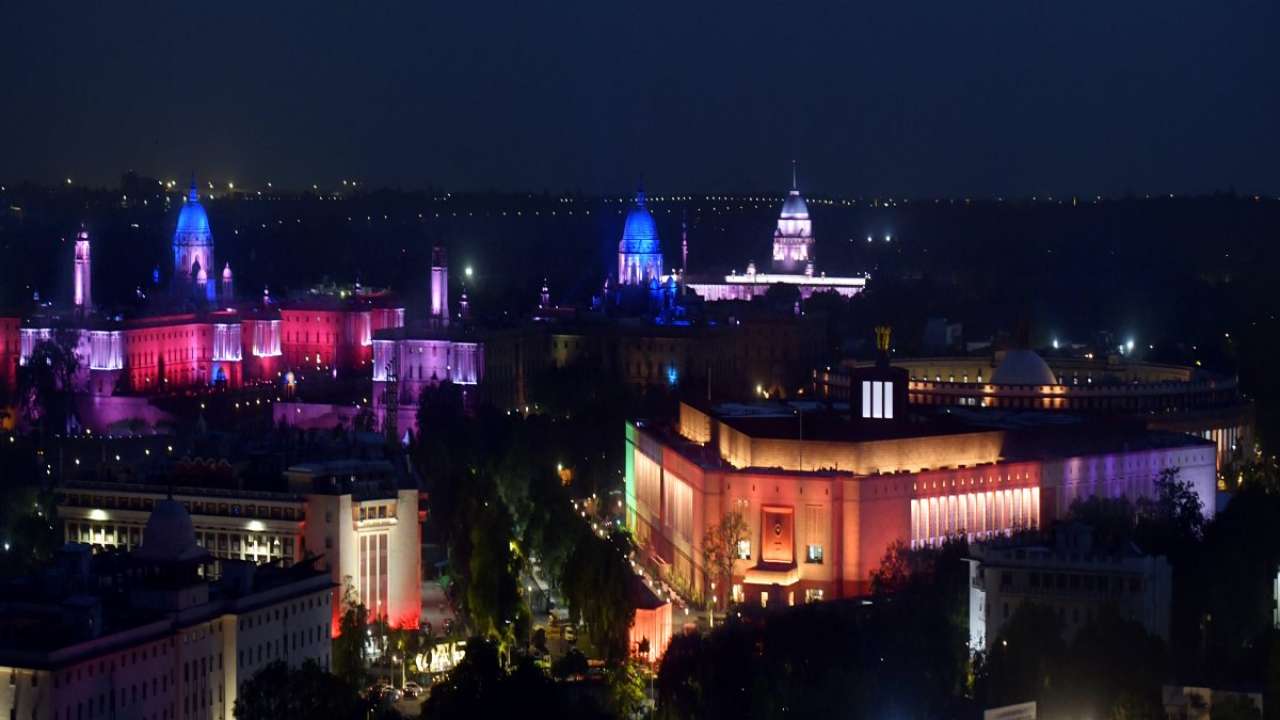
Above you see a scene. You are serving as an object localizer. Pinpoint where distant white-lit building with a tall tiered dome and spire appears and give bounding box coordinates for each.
[685,169,867,302]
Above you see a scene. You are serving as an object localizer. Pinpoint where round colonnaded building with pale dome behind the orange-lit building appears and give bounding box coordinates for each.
[814,348,1254,468]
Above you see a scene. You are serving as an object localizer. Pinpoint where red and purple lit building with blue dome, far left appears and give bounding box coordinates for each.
[0,178,404,430]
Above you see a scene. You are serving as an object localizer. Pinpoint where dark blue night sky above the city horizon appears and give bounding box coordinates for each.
[0,0,1280,197]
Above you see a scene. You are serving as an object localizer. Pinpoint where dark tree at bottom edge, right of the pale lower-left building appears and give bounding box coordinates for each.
[234,660,362,720]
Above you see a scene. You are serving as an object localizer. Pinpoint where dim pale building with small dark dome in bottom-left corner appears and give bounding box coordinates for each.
[0,498,333,720]
